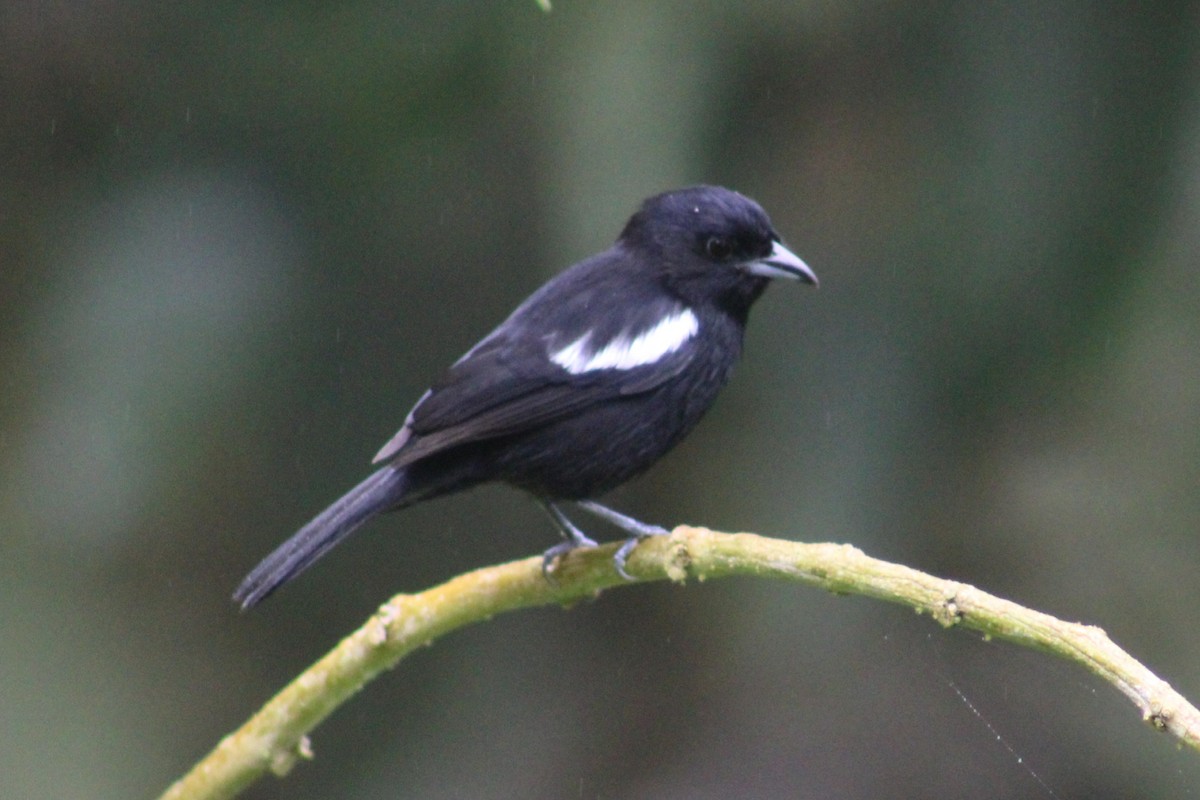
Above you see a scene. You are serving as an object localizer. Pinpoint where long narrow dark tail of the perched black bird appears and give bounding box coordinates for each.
[233,467,407,609]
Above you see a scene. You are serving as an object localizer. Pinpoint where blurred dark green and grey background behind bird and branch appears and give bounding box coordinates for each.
[0,0,1200,799]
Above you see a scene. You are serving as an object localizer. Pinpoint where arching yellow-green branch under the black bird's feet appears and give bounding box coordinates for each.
[162,527,1200,800]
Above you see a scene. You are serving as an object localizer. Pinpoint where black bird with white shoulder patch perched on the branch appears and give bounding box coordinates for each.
[234,186,817,608]
